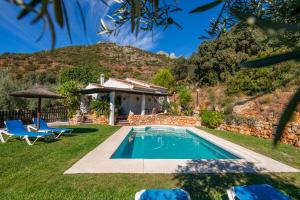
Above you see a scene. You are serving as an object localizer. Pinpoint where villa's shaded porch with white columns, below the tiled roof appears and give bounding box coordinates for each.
[77,88,169,125]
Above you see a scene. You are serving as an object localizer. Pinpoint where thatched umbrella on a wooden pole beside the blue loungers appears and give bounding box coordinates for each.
[9,85,65,129]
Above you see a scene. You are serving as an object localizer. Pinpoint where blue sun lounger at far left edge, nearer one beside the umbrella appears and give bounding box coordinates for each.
[0,120,54,145]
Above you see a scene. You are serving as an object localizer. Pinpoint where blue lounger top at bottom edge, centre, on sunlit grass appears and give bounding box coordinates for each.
[135,189,191,200]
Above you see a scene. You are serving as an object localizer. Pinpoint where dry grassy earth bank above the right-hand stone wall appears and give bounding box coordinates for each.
[193,85,300,123]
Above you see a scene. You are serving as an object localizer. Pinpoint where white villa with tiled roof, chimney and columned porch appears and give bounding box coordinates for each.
[79,74,169,125]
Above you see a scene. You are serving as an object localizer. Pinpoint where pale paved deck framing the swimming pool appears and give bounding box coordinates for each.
[64,125,299,174]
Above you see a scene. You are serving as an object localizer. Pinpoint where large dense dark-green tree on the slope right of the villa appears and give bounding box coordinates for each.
[190,25,265,85]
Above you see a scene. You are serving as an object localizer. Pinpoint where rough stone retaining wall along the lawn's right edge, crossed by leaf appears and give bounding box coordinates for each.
[219,121,300,147]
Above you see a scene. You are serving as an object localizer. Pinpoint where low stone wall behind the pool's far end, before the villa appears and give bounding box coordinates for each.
[128,115,201,126]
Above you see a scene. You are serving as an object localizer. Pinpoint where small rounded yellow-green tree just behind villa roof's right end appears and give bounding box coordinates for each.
[153,68,175,88]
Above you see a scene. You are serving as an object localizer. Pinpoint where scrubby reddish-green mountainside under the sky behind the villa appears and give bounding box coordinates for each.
[0,42,174,82]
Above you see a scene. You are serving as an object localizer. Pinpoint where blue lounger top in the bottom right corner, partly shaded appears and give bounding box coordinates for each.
[227,184,291,200]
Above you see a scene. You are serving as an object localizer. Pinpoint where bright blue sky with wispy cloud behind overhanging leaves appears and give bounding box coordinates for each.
[0,0,220,57]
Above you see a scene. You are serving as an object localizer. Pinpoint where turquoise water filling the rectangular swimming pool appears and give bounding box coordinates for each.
[111,127,239,159]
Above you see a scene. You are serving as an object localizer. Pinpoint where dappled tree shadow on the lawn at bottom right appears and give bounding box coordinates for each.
[173,161,300,200]
